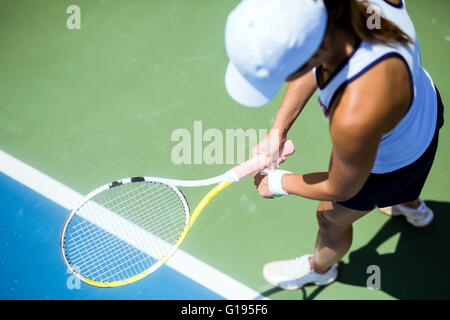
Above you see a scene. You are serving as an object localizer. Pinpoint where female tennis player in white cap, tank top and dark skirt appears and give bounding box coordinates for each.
[225,0,443,289]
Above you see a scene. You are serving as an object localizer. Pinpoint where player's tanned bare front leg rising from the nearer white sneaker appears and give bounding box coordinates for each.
[310,201,370,273]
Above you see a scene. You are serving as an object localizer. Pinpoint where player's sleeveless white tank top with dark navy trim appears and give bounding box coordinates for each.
[314,0,437,173]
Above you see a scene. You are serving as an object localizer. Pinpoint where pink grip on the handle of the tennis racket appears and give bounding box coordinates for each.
[228,140,295,182]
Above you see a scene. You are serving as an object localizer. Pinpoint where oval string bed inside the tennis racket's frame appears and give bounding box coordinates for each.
[64,182,188,282]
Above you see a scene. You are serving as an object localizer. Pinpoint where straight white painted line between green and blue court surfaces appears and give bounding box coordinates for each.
[0,150,267,300]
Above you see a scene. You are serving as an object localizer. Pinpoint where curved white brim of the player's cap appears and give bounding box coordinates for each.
[225,62,284,108]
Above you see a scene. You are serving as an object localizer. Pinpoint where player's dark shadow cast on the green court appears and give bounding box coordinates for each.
[262,201,450,300]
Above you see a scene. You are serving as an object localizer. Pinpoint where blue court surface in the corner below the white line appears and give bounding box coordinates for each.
[0,173,224,300]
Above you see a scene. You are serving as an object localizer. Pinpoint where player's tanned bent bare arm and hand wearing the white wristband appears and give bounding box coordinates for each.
[255,58,411,201]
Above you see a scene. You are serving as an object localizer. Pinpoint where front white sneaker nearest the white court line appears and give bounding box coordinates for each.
[263,254,337,290]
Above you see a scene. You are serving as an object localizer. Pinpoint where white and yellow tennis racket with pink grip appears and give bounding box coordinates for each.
[60,140,295,287]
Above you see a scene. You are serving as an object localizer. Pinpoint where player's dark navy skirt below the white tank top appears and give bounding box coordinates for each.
[338,89,444,211]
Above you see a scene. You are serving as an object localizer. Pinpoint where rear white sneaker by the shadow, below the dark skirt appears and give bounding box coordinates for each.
[379,199,434,228]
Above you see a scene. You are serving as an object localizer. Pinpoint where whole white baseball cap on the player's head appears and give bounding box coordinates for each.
[225,0,327,107]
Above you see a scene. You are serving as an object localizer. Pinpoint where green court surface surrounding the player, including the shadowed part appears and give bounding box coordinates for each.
[0,0,450,299]
